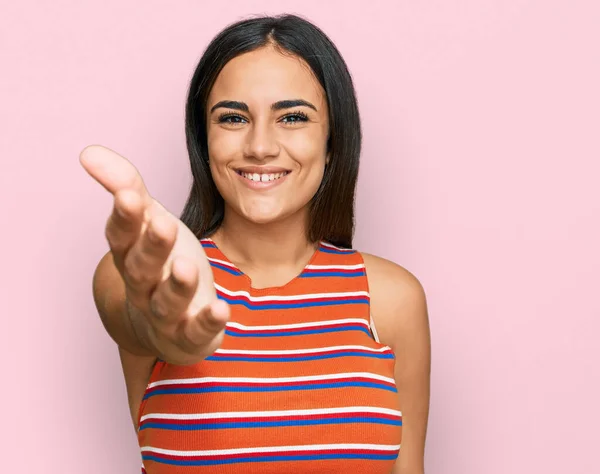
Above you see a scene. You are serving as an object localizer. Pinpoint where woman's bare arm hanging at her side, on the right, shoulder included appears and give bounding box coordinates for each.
[363,254,431,474]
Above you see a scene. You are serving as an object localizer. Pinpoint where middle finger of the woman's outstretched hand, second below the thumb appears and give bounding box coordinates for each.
[123,215,177,308]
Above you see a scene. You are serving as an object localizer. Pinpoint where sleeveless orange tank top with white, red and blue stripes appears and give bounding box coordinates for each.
[138,239,402,474]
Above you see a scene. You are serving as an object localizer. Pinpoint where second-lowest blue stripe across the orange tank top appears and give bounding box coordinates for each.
[140,416,402,431]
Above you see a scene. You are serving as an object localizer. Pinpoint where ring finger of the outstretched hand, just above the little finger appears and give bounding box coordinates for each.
[150,257,199,327]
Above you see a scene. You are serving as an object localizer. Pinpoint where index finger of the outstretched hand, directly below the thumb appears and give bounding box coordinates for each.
[104,190,144,274]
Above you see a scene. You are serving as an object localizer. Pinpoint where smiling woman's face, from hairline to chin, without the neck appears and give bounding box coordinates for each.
[207,46,329,224]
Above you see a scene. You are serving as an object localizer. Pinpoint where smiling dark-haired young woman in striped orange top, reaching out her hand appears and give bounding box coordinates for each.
[80,15,430,474]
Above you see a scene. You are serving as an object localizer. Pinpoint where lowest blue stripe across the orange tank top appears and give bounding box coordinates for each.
[142,451,398,466]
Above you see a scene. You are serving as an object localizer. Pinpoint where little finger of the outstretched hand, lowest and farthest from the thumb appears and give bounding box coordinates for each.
[181,299,230,351]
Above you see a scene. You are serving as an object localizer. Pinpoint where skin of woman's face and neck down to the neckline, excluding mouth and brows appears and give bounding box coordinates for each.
[207,47,329,288]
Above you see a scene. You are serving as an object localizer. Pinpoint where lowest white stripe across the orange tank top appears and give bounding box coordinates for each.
[141,444,400,456]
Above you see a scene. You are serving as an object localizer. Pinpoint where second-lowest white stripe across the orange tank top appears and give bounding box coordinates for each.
[140,407,402,422]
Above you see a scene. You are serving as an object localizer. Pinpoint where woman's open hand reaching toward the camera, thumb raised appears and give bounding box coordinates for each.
[80,145,230,365]
